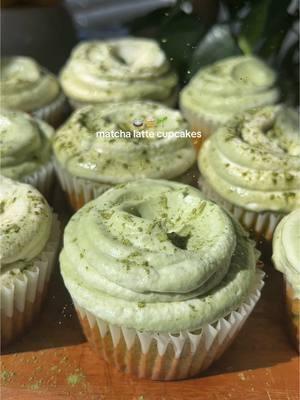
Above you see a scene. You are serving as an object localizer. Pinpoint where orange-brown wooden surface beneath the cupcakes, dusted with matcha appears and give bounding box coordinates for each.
[1,188,300,400]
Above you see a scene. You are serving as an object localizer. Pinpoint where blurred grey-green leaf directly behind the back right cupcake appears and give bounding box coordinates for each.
[189,24,242,77]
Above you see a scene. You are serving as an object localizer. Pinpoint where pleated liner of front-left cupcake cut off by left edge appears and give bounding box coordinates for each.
[1,214,60,345]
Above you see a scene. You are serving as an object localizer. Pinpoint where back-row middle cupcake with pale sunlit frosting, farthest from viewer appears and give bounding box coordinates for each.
[60,38,178,108]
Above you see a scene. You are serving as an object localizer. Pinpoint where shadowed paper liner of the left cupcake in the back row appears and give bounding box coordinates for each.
[31,91,70,127]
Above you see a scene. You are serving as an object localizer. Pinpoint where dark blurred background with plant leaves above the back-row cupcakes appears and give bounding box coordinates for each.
[1,0,299,105]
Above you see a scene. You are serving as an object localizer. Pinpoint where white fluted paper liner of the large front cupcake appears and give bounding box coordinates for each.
[73,270,264,380]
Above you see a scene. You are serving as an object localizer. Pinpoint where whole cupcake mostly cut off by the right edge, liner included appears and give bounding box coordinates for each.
[272,208,300,352]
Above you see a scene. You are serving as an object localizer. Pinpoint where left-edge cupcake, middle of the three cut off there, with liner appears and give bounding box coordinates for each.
[0,109,54,194]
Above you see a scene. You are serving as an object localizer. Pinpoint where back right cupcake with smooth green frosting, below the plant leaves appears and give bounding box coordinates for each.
[180,56,279,151]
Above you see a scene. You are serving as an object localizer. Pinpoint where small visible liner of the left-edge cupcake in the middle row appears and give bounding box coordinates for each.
[21,161,54,197]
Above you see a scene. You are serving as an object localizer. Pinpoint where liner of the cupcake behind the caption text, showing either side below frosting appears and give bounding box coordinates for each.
[54,160,197,210]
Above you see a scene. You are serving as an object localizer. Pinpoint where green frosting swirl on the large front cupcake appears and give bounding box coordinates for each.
[60,179,256,333]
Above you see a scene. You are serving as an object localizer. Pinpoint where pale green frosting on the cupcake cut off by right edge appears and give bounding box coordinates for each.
[272,209,300,298]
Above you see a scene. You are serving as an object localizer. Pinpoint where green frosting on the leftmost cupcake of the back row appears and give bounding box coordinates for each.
[0,57,60,112]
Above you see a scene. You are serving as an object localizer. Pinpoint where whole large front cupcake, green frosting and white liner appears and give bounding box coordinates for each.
[60,179,263,380]
